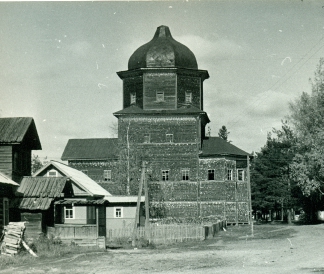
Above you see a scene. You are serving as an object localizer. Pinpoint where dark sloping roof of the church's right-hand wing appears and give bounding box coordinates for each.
[199,137,250,156]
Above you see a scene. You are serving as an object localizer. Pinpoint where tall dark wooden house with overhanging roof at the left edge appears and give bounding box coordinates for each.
[0,117,42,183]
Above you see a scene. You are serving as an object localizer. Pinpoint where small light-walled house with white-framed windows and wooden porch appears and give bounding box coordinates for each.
[18,161,144,238]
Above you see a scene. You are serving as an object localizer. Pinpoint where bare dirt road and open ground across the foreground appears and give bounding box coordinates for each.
[0,224,324,274]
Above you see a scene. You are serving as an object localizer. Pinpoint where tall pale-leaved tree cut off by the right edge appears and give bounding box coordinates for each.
[289,58,324,221]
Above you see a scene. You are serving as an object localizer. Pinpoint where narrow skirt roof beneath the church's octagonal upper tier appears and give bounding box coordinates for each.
[114,105,210,123]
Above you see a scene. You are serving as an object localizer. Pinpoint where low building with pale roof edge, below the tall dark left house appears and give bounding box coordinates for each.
[0,172,19,232]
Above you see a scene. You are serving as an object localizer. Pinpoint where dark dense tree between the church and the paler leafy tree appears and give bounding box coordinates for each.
[251,122,295,222]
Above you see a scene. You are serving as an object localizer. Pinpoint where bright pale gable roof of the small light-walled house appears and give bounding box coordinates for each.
[33,161,111,196]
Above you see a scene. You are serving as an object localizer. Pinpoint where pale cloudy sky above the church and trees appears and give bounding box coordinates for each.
[0,0,324,160]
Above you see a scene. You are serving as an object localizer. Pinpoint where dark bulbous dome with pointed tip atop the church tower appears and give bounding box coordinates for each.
[128,26,198,70]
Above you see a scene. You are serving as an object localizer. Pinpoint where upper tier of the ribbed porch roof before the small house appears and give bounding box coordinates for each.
[17,177,69,198]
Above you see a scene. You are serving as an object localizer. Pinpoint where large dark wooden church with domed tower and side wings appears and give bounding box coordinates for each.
[61,26,251,223]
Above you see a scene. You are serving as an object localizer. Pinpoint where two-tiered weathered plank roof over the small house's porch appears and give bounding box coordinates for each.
[17,177,69,210]
